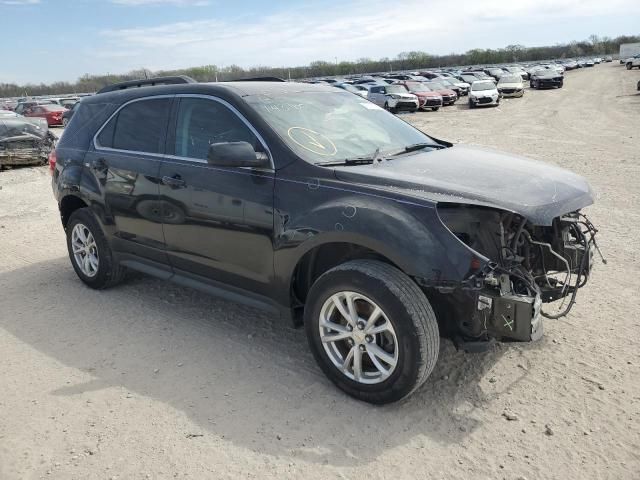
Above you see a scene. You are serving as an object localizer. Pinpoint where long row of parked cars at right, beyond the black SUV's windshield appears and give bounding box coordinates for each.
[316,59,576,112]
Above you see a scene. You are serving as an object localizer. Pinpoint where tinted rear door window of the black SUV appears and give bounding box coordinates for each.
[98,98,172,153]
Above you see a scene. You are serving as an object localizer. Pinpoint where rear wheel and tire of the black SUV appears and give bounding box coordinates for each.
[66,208,125,289]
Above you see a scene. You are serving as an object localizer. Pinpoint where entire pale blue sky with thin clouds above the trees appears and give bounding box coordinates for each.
[0,0,640,83]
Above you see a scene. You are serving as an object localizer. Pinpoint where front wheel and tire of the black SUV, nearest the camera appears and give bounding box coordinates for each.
[305,260,440,404]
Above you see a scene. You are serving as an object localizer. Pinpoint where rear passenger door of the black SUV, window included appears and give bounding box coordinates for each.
[85,96,173,265]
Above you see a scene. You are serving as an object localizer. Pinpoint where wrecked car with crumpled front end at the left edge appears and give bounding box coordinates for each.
[0,117,56,169]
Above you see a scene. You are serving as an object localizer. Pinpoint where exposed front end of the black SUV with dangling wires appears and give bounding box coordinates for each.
[434,204,604,345]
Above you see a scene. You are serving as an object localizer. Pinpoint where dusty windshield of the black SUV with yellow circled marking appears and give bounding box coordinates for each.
[245,91,439,163]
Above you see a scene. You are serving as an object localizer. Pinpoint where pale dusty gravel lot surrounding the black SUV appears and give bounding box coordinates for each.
[0,64,640,480]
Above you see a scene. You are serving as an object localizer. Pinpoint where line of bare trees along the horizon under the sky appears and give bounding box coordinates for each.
[0,35,640,97]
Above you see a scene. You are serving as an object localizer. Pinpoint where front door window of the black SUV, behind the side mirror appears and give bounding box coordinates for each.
[175,98,261,160]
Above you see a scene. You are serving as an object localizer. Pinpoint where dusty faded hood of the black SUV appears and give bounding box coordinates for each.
[335,145,593,225]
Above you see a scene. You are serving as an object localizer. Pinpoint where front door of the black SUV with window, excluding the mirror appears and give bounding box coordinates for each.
[159,95,274,294]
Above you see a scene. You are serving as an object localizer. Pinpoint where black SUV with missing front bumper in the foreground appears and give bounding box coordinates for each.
[51,78,595,403]
